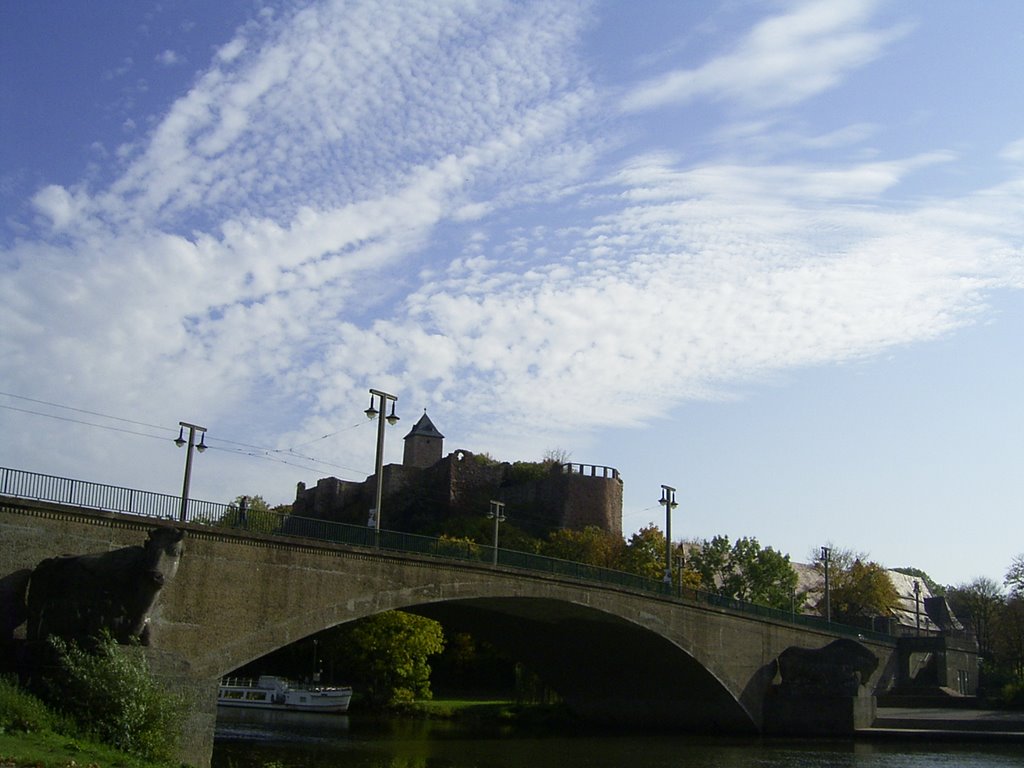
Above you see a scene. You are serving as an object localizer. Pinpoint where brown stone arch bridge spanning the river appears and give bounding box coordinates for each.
[0,499,896,765]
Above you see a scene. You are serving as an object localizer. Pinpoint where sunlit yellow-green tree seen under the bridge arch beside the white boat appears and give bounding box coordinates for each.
[340,610,444,706]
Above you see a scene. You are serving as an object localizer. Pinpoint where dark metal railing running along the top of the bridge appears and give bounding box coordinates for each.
[0,467,895,642]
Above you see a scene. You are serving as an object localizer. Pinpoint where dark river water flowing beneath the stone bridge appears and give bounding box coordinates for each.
[212,710,1024,768]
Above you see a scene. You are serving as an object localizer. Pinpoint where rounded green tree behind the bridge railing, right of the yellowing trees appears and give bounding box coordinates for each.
[687,536,803,609]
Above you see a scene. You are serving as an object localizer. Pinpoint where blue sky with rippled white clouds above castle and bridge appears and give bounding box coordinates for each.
[0,0,1024,585]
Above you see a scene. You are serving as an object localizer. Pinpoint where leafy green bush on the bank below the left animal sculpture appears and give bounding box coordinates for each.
[43,633,183,761]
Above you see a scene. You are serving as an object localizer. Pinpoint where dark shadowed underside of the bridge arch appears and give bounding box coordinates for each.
[408,598,757,733]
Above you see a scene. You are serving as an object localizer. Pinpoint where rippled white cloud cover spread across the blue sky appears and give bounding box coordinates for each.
[0,2,1024,507]
